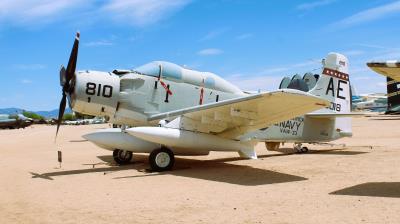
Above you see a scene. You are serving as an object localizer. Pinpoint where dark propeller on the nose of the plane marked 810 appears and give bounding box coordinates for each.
[56,32,80,138]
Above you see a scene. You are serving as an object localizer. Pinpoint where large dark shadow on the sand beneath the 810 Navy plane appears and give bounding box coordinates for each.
[31,155,307,186]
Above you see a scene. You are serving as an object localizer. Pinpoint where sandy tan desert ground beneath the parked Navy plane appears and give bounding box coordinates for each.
[0,117,400,224]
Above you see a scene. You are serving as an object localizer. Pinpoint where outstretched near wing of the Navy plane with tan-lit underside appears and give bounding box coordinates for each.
[149,89,329,139]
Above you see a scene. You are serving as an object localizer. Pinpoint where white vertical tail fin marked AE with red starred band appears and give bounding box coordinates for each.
[309,53,351,136]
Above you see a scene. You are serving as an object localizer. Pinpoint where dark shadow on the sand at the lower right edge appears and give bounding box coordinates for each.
[330,182,400,198]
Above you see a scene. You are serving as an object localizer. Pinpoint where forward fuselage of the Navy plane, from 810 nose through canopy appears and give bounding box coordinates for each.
[70,61,248,126]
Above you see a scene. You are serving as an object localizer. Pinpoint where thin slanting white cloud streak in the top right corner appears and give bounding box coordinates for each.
[332,1,400,28]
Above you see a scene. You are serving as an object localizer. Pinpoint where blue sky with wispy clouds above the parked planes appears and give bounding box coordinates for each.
[0,0,400,110]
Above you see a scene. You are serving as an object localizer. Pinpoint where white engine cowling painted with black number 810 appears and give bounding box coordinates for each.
[69,71,120,117]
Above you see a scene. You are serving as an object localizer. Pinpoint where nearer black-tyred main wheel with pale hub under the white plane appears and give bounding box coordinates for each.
[149,147,175,171]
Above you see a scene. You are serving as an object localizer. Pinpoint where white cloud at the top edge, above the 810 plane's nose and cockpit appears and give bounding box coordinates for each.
[100,0,190,26]
